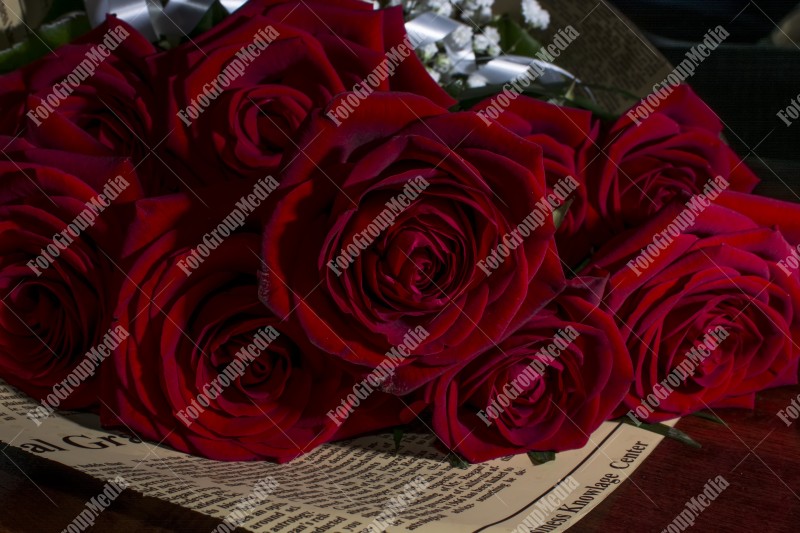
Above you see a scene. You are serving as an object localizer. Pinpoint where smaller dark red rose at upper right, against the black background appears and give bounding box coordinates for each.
[589,85,758,237]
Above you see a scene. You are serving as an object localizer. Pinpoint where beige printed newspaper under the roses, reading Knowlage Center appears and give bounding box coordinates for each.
[0,382,676,533]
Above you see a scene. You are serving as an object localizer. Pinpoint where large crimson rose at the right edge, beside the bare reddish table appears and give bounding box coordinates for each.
[594,197,800,422]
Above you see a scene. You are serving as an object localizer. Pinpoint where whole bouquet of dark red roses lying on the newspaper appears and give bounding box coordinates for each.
[0,0,800,461]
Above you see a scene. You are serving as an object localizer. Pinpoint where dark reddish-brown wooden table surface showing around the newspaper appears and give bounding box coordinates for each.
[0,380,800,533]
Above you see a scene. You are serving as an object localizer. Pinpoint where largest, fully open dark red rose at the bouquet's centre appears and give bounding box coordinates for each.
[262,93,564,394]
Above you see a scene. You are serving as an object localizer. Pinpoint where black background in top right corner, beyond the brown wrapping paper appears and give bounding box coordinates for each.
[612,0,800,183]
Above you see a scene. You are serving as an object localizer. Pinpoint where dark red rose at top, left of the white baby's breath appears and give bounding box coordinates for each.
[158,0,454,188]
